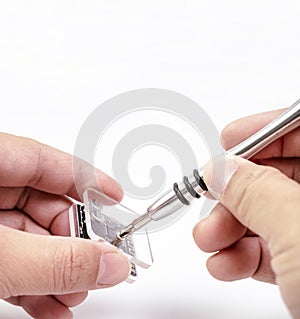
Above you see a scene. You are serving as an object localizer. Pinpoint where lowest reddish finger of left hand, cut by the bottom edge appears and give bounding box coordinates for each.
[6,296,73,319]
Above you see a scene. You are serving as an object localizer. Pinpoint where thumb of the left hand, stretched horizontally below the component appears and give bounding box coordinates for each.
[0,226,130,299]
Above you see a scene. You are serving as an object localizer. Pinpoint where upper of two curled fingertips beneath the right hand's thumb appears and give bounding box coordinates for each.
[193,204,247,252]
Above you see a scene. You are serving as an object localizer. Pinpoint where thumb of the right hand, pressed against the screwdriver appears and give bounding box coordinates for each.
[204,156,300,254]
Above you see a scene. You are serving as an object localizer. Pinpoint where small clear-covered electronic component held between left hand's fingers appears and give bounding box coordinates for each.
[69,189,153,282]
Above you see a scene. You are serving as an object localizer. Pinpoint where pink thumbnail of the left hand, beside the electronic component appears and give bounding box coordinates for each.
[97,252,130,286]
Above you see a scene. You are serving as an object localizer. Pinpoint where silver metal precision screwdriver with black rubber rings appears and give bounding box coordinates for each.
[112,100,300,246]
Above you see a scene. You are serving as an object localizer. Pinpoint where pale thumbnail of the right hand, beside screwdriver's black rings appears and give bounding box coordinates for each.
[203,155,237,199]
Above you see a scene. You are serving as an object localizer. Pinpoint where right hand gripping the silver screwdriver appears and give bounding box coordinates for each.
[194,111,300,318]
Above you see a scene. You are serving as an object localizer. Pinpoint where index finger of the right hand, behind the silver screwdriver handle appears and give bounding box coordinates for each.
[221,110,300,159]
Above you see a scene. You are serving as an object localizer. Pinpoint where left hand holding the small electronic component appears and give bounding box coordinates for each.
[0,134,130,319]
